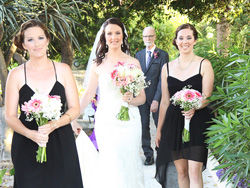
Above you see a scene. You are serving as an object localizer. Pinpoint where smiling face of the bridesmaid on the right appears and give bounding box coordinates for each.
[175,29,196,53]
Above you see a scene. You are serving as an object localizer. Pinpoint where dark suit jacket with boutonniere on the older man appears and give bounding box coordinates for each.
[135,47,169,105]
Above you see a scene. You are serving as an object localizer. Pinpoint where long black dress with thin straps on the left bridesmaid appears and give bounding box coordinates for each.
[11,63,83,188]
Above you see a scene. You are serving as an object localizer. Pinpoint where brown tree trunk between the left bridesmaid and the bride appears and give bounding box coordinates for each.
[61,35,73,67]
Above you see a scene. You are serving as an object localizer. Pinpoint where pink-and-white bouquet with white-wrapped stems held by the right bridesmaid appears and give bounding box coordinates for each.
[170,85,204,142]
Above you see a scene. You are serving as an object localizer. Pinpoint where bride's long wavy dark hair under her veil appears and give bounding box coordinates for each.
[94,18,130,65]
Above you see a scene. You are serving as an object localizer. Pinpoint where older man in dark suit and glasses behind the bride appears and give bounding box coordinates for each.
[135,26,169,165]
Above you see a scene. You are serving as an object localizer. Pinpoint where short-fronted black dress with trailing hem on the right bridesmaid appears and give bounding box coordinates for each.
[156,60,211,188]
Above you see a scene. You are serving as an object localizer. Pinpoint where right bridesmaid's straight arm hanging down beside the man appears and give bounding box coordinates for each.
[155,64,170,147]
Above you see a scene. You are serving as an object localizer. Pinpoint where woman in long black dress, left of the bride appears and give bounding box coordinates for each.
[5,20,83,188]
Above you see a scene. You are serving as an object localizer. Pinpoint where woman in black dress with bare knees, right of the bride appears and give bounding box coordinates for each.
[156,24,214,188]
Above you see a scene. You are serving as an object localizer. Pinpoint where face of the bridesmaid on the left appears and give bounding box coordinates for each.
[23,26,49,57]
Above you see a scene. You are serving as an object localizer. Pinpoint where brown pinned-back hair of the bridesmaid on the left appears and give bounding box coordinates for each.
[13,20,49,50]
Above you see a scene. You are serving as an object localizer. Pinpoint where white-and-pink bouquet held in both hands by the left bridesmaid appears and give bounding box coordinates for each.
[21,91,62,163]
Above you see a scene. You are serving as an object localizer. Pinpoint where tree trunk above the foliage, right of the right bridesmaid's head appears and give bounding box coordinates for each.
[216,16,230,55]
